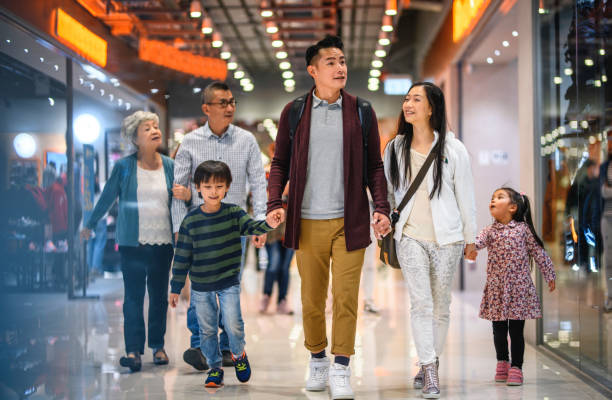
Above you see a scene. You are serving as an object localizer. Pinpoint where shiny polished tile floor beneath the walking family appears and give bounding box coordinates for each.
[0,260,606,400]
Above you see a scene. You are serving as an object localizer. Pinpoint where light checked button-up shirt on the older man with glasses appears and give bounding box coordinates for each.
[172,123,268,232]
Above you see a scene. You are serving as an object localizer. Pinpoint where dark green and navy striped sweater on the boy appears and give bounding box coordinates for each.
[170,203,273,293]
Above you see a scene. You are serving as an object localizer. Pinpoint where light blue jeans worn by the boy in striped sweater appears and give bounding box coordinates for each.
[191,285,244,368]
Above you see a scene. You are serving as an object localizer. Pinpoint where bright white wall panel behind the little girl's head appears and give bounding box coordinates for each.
[463,60,524,292]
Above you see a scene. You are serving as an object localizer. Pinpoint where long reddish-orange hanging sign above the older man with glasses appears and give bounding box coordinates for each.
[138,39,227,81]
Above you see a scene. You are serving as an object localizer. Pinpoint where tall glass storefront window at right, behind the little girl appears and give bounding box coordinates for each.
[536,0,612,386]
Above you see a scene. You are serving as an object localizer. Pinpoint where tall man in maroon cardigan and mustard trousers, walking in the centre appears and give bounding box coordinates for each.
[268,36,390,399]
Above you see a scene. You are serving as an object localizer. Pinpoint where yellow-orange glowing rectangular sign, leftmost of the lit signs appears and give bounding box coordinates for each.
[55,8,107,67]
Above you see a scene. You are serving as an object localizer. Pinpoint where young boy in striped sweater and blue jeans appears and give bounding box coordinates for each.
[169,160,278,388]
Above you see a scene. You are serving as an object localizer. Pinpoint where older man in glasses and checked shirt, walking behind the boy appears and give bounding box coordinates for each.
[172,82,266,370]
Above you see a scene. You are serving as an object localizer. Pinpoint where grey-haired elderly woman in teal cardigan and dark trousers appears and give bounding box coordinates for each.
[81,111,187,371]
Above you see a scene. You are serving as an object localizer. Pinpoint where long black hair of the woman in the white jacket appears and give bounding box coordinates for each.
[390,82,446,199]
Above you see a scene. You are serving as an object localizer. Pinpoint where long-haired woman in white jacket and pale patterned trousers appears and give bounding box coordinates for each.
[385,83,476,398]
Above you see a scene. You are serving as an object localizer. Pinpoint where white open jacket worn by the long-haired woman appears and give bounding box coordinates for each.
[384,132,476,246]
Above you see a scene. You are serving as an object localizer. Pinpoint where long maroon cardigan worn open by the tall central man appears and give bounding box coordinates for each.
[268,90,390,251]
